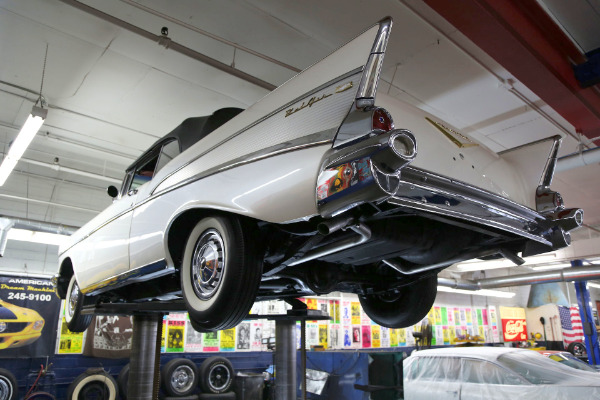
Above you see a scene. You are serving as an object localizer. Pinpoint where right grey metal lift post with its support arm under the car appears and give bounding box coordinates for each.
[248,299,331,400]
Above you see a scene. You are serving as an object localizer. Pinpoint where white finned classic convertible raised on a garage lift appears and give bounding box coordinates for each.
[55,18,582,331]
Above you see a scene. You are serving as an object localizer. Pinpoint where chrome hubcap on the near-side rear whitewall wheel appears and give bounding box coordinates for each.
[191,229,225,300]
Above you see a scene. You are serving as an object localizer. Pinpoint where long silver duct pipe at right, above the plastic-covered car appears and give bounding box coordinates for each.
[438,265,600,290]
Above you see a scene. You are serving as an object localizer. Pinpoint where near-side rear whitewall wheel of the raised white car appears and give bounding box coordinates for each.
[181,216,262,331]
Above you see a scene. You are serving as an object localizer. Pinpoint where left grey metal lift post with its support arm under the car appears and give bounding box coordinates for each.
[82,301,187,400]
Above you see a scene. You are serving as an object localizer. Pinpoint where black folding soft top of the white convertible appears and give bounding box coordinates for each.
[127,107,244,170]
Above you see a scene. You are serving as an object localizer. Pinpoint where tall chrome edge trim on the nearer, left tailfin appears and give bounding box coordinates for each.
[356,17,392,108]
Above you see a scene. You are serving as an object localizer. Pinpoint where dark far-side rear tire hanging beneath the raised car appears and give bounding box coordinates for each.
[358,276,437,328]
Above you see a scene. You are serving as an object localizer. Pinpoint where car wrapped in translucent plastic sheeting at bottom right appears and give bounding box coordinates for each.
[404,347,600,400]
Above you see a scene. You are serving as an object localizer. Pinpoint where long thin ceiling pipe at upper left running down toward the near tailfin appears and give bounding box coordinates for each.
[60,0,277,91]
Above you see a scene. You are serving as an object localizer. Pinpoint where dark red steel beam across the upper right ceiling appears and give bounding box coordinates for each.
[424,0,600,144]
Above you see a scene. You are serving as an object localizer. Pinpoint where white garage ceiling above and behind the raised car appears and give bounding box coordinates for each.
[0,0,600,273]
